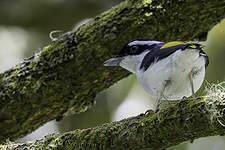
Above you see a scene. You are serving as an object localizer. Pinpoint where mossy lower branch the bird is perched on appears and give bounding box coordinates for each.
[1,96,225,150]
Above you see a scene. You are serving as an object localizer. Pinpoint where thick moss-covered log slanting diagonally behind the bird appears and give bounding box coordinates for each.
[0,0,225,142]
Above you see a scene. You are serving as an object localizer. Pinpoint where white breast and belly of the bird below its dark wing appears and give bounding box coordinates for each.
[136,49,205,100]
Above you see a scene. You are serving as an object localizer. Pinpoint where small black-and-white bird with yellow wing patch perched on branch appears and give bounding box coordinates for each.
[104,39,209,110]
